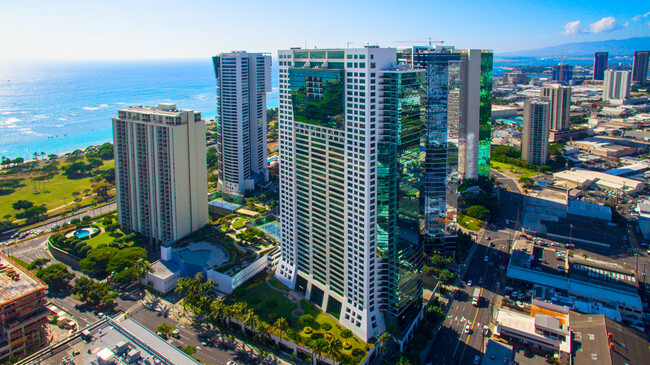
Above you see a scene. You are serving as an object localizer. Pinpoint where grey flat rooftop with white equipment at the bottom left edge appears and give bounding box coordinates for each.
[23,315,200,365]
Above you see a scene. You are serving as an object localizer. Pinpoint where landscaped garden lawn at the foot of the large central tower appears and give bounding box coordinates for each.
[232,278,366,354]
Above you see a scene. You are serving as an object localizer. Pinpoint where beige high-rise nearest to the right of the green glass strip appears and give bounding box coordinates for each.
[521,98,550,165]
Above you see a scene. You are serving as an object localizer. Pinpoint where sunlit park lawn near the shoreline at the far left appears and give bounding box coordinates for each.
[0,160,115,217]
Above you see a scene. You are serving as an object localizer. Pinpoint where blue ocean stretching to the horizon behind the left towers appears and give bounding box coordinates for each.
[0,58,278,159]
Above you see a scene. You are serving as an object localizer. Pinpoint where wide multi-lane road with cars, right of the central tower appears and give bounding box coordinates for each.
[425,230,512,365]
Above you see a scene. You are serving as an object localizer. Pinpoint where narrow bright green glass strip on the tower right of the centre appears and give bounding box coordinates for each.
[478,51,494,178]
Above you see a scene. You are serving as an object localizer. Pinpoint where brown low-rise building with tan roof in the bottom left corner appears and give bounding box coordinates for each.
[0,254,49,363]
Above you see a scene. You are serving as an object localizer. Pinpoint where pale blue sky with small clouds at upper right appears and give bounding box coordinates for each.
[0,0,650,60]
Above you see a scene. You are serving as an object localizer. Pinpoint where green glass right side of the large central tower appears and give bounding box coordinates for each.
[377,71,426,330]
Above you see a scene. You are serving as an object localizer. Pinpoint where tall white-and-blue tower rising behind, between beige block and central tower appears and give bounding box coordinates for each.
[212,52,271,195]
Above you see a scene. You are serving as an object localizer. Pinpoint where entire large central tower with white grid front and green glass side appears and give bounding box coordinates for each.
[275,47,426,340]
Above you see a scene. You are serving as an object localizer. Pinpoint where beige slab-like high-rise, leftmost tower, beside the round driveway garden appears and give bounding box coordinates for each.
[113,104,208,243]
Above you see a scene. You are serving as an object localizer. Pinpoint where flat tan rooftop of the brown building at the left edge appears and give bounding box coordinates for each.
[0,254,47,305]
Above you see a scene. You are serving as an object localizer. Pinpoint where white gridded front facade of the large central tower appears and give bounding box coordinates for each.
[275,47,416,341]
